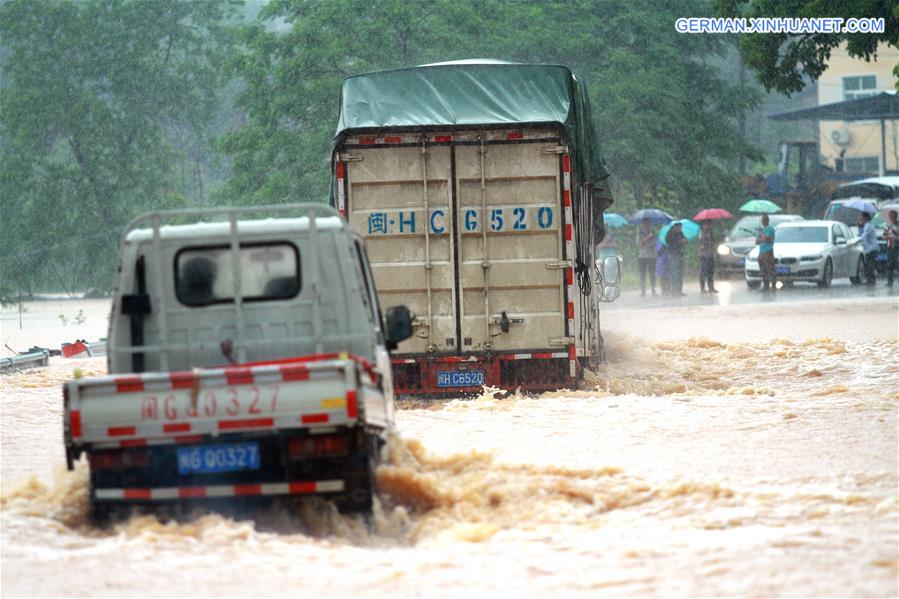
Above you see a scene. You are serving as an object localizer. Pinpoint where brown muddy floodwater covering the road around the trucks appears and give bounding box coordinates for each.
[0,296,899,597]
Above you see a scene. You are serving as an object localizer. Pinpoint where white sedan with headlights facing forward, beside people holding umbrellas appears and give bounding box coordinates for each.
[745,220,865,289]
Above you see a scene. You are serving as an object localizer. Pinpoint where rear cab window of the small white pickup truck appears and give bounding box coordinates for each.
[175,242,301,306]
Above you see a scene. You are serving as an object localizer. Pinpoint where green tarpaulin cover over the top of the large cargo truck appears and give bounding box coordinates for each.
[336,60,611,196]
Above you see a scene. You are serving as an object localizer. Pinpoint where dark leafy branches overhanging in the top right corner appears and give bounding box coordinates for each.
[715,0,899,95]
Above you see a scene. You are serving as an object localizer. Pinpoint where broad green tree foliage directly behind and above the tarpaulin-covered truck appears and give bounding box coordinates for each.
[221,0,760,221]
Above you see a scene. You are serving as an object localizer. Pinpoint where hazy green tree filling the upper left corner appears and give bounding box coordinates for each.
[0,0,239,290]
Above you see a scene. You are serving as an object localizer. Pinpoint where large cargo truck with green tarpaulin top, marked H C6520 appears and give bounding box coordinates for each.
[331,60,619,396]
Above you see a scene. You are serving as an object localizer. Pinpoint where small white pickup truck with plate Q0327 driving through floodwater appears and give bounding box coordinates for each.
[63,204,411,522]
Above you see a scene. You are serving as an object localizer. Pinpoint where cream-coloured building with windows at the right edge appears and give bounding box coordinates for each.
[818,44,899,176]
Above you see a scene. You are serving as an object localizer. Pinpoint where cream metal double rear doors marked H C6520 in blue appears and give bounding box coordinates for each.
[337,131,568,353]
